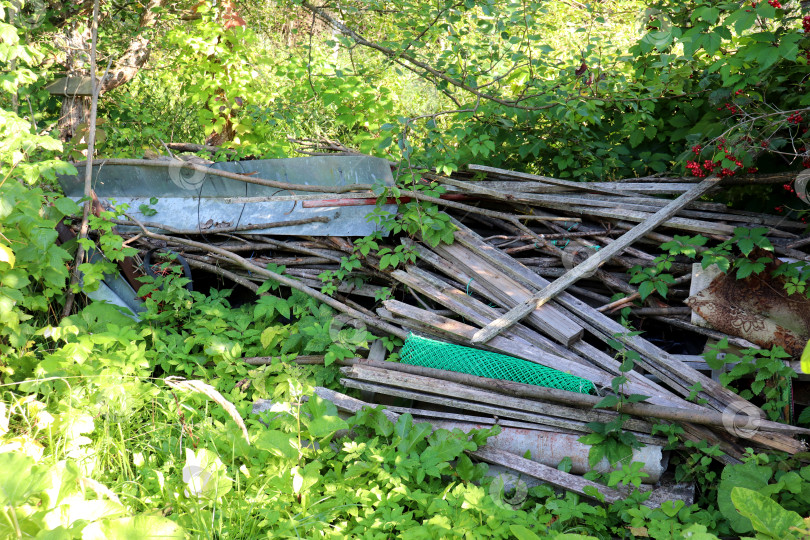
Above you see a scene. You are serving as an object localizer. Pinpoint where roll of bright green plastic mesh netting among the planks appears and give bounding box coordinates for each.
[400,334,595,394]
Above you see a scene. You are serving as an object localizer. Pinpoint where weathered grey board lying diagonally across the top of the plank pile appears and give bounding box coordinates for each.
[471,176,722,344]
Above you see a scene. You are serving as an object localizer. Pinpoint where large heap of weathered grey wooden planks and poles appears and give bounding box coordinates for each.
[72,155,810,490]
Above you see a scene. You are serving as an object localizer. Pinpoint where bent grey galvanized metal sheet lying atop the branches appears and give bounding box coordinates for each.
[59,156,396,236]
